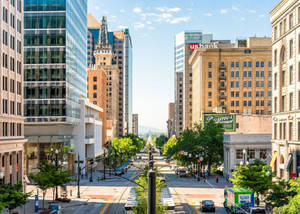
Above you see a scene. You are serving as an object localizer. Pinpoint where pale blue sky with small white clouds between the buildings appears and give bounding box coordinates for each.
[88,0,280,130]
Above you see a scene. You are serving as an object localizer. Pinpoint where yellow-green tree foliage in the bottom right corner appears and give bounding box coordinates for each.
[275,178,300,214]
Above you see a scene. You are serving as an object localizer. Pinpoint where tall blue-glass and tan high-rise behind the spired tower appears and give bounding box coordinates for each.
[88,15,132,136]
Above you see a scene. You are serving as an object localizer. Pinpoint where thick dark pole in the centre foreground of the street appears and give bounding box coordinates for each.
[147,169,156,214]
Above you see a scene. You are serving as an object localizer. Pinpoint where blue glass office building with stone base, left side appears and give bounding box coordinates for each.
[24,0,87,172]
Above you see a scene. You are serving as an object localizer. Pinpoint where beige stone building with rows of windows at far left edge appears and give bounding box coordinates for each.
[0,1,26,184]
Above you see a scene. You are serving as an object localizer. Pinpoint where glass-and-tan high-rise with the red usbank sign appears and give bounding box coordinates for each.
[174,31,213,136]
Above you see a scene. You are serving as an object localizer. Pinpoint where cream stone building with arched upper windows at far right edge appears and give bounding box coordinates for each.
[270,0,300,180]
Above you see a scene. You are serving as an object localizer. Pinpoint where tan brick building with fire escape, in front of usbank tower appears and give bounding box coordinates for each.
[190,37,272,124]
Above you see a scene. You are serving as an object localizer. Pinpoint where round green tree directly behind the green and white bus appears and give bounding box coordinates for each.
[230,160,273,206]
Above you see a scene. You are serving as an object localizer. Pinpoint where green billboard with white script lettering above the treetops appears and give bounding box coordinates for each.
[203,114,236,132]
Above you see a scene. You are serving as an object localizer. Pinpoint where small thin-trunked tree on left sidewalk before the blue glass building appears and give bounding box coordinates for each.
[29,161,57,209]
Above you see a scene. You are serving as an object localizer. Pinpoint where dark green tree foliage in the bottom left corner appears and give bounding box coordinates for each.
[0,182,31,213]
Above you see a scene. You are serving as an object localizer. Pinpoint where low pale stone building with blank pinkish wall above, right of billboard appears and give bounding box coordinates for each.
[224,115,272,177]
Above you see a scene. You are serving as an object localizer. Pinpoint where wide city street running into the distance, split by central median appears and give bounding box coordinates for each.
[15,150,228,214]
